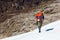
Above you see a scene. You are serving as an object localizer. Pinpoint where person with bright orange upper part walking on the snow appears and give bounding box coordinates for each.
[35,11,44,32]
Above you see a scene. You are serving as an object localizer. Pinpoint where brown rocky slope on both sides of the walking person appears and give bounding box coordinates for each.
[0,2,60,38]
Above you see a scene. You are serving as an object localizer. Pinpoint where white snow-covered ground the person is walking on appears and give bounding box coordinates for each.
[0,20,60,40]
